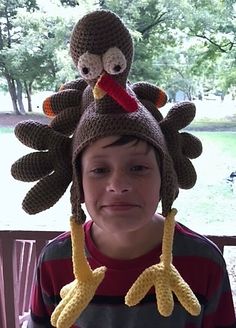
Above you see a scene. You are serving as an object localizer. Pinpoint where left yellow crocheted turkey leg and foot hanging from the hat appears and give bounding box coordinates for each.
[51,217,106,328]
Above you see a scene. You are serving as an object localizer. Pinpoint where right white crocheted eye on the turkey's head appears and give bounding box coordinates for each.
[102,47,127,75]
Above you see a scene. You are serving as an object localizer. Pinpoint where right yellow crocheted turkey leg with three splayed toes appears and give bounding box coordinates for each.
[125,209,201,317]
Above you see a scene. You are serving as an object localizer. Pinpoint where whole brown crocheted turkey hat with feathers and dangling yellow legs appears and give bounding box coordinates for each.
[11,10,202,328]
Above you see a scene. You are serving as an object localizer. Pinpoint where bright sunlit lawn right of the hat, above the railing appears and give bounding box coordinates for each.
[159,130,236,235]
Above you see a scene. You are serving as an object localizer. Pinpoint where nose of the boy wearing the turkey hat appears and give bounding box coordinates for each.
[107,173,131,194]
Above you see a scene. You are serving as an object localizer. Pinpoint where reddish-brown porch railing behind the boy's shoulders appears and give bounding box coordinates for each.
[0,231,236,328]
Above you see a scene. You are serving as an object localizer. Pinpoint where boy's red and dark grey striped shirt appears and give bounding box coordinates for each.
[28,221,236,328]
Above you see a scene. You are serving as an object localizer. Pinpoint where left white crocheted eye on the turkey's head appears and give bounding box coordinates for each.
[77,52,103,80]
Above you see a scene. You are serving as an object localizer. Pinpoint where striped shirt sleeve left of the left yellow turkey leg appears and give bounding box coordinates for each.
[28,232,74,328]
